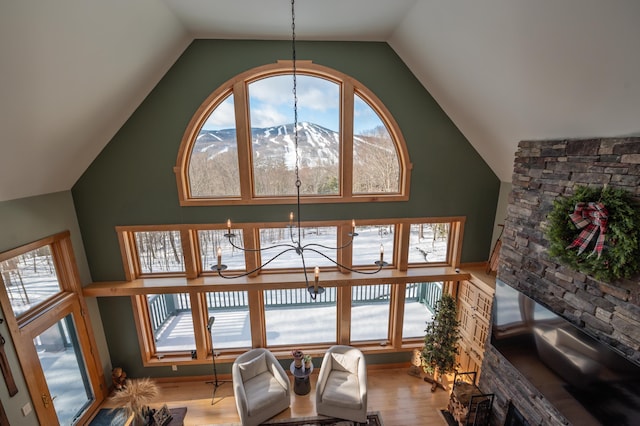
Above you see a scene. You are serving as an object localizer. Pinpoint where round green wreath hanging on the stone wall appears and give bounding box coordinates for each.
[546,186,640,282]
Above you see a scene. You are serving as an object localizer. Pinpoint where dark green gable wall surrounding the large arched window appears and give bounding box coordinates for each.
[72,40,500,375]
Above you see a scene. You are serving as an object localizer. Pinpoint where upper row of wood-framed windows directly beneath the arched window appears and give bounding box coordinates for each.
[117,217,464,280]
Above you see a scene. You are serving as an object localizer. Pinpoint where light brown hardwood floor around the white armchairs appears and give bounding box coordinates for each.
[94,368,449,426]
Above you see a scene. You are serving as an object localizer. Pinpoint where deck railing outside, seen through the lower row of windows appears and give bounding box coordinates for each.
[149,282,442,334]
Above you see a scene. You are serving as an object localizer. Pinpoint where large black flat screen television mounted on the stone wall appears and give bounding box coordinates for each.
[491,280,640,426]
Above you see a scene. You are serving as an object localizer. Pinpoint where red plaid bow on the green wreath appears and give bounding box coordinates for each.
[567,202,609,258]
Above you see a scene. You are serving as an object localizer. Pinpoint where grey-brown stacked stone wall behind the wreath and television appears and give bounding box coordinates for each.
[479,137,640,425]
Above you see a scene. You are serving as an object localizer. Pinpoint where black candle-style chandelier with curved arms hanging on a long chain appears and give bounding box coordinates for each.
[211,0,388,300]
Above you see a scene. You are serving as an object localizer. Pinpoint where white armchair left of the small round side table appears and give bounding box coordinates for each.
[231,348,291,426]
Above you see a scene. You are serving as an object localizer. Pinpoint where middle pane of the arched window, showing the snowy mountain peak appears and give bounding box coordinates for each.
[248,74,340,197]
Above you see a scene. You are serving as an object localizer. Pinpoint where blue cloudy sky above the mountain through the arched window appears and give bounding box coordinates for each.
[203,75,381,134]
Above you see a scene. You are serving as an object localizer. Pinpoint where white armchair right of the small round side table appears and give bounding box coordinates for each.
[316,345,367,423]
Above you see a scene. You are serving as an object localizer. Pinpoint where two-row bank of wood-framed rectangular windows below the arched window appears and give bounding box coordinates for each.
[115,217,465,365]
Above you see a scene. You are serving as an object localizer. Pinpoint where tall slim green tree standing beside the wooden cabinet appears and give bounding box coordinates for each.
[420,294,460,392]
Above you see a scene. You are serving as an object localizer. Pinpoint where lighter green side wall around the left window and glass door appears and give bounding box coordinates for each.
[0,191,111,426]
